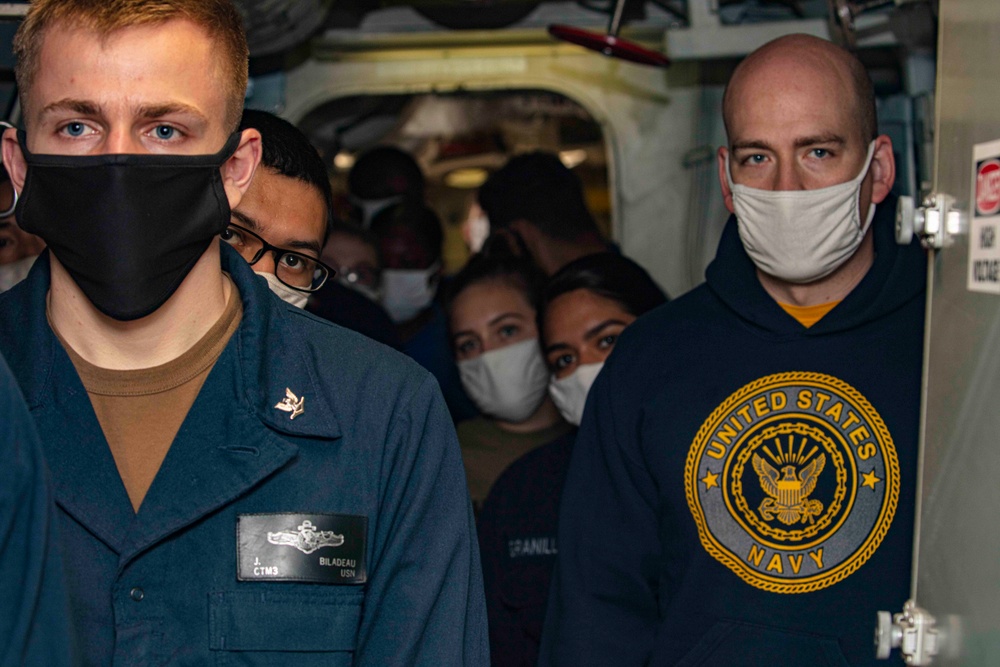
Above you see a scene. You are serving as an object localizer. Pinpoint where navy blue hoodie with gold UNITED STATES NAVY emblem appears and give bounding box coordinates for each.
[541,198,926,667]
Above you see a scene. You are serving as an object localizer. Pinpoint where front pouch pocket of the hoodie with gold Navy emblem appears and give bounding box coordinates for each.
[675,621,849,667]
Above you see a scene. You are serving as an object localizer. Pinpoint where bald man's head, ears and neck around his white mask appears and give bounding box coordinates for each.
[717,35,896,305]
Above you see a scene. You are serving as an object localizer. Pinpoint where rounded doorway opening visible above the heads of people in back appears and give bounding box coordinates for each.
[299,90,612,273]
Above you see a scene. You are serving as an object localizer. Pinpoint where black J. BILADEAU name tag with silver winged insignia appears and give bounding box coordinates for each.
[236,513,368,584]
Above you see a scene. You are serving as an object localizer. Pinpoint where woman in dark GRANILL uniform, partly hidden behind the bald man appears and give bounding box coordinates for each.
[478,252,666,667]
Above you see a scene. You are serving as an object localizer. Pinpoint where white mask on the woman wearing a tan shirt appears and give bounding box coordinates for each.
[458,338,549,424]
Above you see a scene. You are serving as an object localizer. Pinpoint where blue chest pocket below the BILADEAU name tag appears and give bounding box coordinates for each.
[208,587,364,667]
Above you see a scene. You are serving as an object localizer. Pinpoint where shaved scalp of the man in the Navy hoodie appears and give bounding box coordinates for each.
[722,35,878,145]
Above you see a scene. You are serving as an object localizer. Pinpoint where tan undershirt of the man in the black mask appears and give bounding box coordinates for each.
[49,276,243,512]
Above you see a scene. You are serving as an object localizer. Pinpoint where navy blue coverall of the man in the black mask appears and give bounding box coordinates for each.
[0,244,488,667]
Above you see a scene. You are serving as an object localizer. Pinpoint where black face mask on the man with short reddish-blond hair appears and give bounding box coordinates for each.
[14,132,240,321]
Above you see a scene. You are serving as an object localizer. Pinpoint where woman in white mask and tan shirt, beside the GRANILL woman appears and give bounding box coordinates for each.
[446,239,570,511]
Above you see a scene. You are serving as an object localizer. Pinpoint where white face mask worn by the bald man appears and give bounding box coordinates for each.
[726,141,875,284]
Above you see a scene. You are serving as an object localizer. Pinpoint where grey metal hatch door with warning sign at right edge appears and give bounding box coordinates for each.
[894,0,1000,667]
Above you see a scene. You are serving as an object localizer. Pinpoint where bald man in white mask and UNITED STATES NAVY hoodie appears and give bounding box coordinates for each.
[541,35,925,667]
